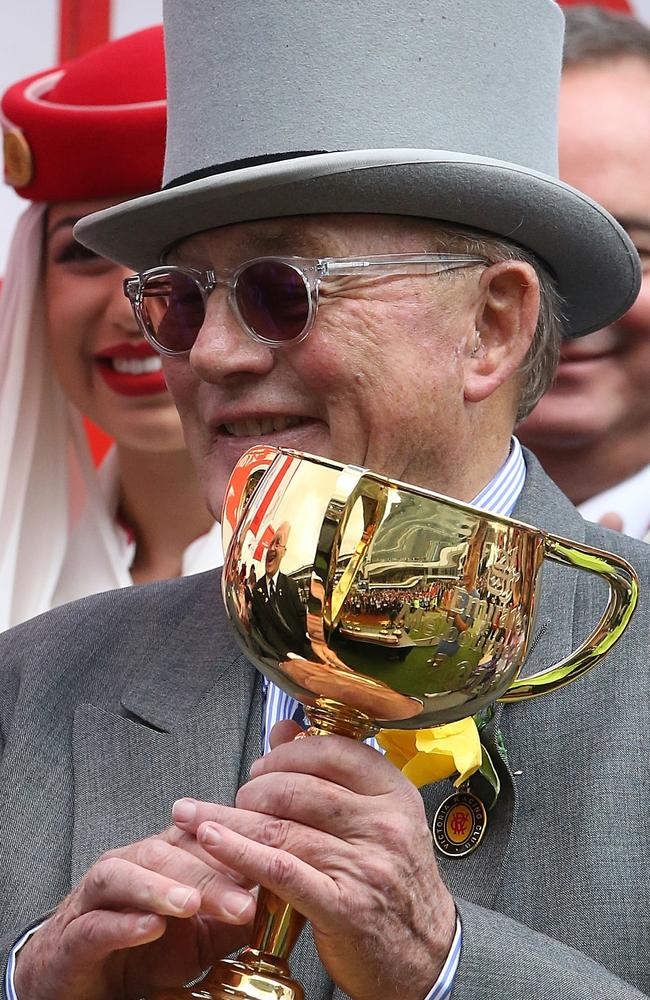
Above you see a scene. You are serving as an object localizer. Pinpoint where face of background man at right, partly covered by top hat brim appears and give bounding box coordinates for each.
[521,58,650,452]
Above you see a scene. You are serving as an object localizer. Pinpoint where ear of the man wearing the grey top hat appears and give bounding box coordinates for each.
[465,260,539,403]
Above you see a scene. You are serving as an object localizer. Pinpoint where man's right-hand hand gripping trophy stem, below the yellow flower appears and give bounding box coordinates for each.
[174,722,455,1000]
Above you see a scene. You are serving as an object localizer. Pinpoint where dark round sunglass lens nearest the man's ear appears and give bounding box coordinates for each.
[235,260,309,344]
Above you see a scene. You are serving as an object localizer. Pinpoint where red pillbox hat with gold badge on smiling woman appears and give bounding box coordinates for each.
[0,25,165,202]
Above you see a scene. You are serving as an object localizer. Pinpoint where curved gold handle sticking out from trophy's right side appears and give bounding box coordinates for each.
[498,535,639,701]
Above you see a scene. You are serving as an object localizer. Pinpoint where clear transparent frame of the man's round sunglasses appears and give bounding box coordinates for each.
[124,253,490,357]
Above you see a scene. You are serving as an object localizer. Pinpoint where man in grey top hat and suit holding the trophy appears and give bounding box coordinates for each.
[0,0,650,1000]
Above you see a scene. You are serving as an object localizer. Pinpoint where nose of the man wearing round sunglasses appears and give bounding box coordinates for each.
[189,288,275,382]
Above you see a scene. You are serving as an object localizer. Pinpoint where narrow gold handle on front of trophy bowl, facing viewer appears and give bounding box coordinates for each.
[314,466,388,627]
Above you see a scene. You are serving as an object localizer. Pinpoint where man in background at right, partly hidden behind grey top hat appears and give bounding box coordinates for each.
[518,8,650,538]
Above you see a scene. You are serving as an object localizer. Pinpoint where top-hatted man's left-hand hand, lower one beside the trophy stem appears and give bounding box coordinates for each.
[15,827,255,1000]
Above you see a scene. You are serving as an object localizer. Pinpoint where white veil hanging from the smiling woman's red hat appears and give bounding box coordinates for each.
[0,204,132,631]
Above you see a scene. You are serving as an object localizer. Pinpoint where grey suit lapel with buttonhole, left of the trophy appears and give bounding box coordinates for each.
[72,588,255,882]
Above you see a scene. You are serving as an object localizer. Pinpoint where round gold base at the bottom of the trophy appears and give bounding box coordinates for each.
[156,949,305,1000]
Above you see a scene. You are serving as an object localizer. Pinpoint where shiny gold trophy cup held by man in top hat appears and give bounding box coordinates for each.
[159,447,638,1000]
